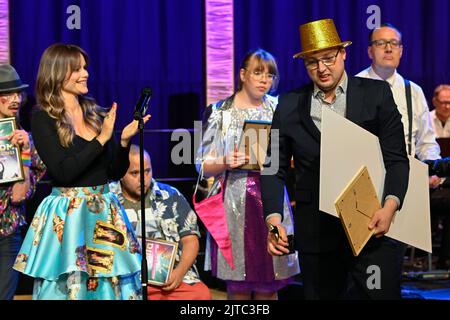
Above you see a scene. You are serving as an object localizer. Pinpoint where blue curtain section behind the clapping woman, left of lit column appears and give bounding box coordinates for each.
[10,0,204,177]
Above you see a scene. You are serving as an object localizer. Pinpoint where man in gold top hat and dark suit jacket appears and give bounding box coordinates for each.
[261,19,409,299]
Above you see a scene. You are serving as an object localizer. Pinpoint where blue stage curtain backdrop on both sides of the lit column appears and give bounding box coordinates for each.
[10,0,450,177]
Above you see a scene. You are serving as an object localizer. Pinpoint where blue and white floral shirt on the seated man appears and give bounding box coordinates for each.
[109,179,200,284]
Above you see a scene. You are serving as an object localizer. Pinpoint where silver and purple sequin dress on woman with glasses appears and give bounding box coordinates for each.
[196,96,299,291]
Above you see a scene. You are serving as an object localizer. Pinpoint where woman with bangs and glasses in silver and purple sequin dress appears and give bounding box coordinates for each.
[196,49,299,300]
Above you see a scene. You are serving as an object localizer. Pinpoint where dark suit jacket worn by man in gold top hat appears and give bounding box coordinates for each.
[261,77,409,253]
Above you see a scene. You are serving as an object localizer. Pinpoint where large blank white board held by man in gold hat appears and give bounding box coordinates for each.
[319,108,432,252]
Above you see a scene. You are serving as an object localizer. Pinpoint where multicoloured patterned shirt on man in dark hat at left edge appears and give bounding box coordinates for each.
[0,133,45,238]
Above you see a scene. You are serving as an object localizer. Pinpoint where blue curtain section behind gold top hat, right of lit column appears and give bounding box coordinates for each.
[234,0,450,101]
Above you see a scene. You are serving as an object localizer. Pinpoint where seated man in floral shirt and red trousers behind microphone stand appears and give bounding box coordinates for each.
[110,145,211,300]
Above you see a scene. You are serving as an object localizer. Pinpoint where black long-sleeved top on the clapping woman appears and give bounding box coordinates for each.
[31,110,130,187]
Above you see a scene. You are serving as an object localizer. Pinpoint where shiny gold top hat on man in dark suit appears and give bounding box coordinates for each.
[294,19,352,58]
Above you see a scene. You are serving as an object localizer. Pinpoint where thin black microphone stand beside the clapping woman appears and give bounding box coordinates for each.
[135,112,148,300]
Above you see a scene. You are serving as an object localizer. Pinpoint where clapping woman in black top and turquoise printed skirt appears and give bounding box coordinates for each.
[14,44,150,300]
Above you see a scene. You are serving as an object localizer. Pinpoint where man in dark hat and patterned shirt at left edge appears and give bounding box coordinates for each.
[0,64,45,300]
